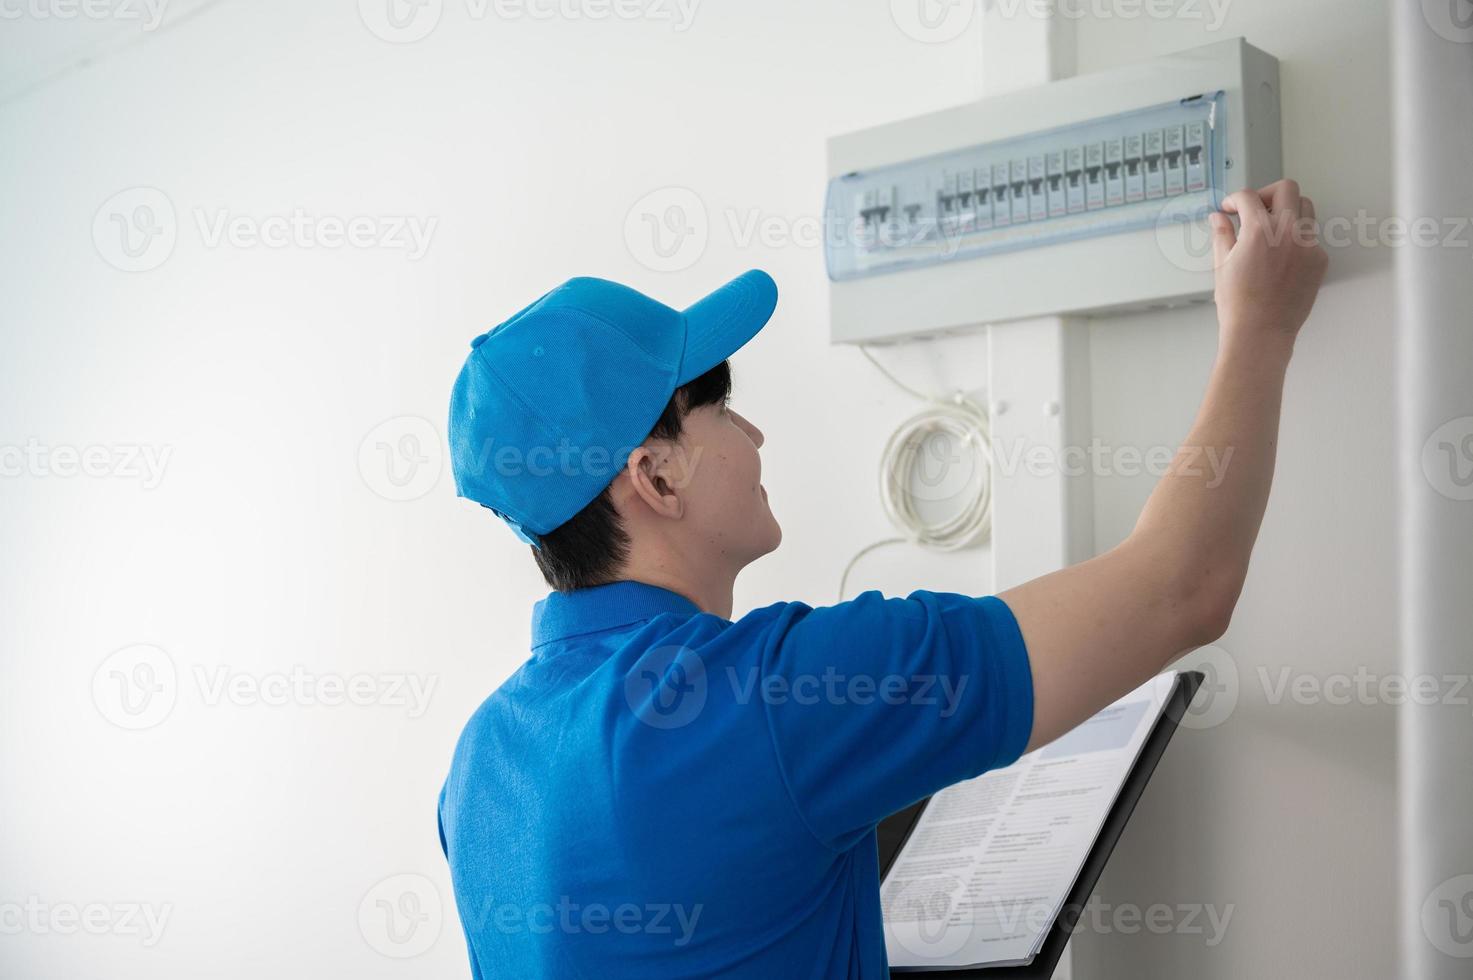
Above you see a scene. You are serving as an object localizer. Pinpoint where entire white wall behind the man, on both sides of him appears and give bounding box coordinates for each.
[0,0,1395,980]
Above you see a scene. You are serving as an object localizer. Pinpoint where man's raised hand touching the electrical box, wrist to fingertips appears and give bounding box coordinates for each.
[1211,180,1330,348]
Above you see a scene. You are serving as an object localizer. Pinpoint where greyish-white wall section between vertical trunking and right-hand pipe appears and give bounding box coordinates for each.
[1074,0,1398,980]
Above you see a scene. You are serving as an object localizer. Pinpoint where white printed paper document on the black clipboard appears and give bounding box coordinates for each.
[879,673,1177,970]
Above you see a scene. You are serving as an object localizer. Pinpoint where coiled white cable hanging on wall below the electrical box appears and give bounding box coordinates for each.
[838,346,993,601]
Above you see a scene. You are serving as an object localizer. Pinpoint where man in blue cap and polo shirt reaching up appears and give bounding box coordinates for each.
[439,181,1326,980]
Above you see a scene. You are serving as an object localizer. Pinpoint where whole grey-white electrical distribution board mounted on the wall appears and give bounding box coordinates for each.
[825,38,1282,342]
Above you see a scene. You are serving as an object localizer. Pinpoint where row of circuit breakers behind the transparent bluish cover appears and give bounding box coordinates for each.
[826,93,1223,280]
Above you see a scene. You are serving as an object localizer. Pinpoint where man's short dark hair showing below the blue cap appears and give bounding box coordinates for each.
[532,361,732,592]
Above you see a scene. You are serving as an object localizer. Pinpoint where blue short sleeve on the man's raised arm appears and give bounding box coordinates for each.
[762,592,1033,849]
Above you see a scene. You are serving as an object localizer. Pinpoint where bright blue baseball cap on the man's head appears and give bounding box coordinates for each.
[449,270,778,547]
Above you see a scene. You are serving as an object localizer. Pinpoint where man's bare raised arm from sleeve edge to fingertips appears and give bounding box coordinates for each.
[1000,180,1327,749]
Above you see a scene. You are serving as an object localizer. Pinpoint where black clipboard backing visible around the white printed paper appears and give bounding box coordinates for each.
[875,671,1203,980]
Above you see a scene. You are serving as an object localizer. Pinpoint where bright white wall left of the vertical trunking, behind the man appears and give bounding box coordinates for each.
[0,0,985,980]
